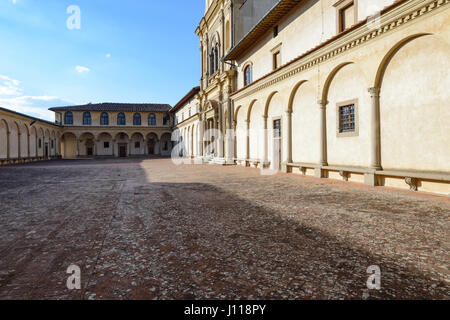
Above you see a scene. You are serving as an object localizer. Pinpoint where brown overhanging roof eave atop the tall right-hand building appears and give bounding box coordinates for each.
[224,0,303,60]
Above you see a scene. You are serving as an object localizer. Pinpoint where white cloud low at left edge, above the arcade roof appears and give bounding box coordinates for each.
[0,75,72,121]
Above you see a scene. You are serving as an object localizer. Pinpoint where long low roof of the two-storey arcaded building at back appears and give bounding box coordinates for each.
[49,102,172,112]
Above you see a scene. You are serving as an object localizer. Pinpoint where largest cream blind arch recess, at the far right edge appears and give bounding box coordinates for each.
[374,33,450,172]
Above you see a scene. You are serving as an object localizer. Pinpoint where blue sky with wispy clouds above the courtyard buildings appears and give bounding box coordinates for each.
[0,0,204,120]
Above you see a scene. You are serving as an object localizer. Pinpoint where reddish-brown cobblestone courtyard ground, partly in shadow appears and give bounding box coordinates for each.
[0,159,450,299]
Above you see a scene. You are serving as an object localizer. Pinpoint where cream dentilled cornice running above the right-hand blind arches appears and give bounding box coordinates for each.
[231,0,450,100]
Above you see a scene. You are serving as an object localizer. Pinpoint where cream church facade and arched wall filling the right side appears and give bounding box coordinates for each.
[180,0,450,194]
